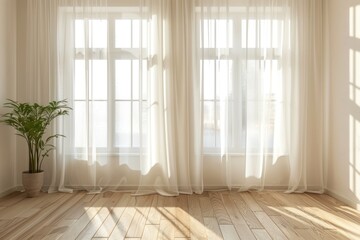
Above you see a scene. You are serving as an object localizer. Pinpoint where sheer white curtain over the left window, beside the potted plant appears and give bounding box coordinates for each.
[55,1,203,195]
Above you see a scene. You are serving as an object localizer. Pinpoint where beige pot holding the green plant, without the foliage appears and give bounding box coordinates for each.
[22,171,44,197]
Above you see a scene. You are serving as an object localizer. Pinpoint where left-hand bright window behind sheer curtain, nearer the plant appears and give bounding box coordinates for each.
[73,12,148,152]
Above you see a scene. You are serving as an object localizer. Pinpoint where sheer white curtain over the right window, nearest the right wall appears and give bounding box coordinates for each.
[196,0,323,192]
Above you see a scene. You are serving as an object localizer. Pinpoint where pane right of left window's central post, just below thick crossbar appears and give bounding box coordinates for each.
[115,60,131,100]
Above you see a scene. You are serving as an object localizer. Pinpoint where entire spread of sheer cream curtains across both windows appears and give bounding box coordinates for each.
[23,0,323,195]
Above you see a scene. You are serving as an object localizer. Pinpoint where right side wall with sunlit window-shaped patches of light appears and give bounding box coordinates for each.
[327,0,360,208]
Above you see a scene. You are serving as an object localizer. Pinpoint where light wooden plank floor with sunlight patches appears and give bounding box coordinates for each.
[0,192,360,240]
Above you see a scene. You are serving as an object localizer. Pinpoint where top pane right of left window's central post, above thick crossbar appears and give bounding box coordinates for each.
[115,19,131,48]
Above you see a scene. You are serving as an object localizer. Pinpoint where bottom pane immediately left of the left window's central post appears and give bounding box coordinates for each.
[91,101,107,147]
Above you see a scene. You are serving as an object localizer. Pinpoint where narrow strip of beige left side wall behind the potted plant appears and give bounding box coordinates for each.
[0,0,16,196]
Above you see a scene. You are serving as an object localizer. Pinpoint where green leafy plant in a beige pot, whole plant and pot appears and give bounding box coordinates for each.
[0,99,71,197]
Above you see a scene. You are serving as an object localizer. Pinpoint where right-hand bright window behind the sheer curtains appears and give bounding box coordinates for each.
[197,9,284,153]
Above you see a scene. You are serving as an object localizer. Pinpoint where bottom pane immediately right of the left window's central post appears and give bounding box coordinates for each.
[115,101,131,147]
